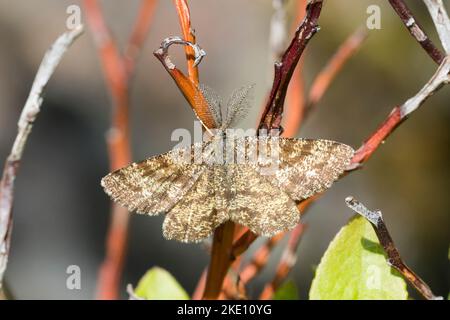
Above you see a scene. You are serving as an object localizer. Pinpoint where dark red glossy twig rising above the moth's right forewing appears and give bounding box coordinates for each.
[259,0,323,129]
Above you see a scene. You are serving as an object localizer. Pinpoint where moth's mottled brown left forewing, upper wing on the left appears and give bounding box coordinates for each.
[101,144,205,215]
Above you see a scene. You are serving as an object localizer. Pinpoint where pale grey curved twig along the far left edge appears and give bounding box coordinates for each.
[0,26,83,289]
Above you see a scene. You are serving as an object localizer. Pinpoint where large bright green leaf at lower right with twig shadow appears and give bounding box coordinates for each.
[309,216,408,300]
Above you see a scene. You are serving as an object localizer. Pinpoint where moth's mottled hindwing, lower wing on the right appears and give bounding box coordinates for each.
[227,164,300,237]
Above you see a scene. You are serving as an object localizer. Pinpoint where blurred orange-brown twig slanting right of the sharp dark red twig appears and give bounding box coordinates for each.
[304,28,367,117]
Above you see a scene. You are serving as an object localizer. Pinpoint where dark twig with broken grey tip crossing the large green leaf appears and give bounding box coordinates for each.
[345,197,442,300]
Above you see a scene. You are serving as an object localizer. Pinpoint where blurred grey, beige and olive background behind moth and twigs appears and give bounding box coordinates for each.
[0,0,450,299]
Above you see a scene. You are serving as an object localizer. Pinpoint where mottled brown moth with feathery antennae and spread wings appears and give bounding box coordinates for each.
[101,86,354,242]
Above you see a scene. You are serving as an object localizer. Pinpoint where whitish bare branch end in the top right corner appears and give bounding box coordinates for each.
[423,0,450,55]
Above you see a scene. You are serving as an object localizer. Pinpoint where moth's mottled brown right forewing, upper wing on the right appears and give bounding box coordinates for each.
[251,138,354,201]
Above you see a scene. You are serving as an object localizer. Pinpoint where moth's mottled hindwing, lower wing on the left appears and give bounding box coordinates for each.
[163,165,229,242]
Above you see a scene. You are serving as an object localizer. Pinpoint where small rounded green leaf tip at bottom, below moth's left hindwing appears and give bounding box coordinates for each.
[135,267,189,300]
